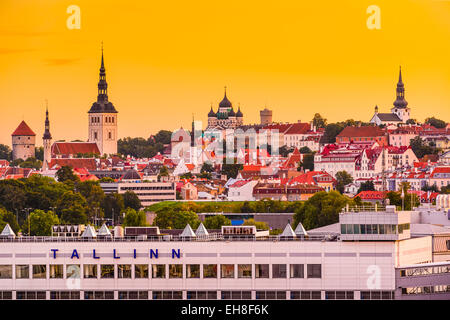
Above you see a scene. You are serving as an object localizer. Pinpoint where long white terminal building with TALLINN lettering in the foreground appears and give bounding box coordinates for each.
[0,206,450,300]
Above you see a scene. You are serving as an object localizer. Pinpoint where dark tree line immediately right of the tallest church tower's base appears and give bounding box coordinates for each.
[117,130,172,158]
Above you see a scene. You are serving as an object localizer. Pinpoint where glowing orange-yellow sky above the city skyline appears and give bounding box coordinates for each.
[0,0,450,145]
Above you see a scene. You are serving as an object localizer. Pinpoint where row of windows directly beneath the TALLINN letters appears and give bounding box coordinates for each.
[0,264,322,279]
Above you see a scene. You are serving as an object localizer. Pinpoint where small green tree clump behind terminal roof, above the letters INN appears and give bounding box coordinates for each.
[154,209,200,229]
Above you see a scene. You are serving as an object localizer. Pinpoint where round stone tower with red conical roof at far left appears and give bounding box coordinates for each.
[11,121,36,160]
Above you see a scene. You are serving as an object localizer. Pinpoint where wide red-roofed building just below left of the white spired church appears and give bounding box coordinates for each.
[336,126,388,146]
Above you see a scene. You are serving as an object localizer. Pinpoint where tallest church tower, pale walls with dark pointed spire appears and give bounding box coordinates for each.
[88,47,118,155]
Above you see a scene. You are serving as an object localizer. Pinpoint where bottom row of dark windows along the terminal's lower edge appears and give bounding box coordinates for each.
[0,286,394,300]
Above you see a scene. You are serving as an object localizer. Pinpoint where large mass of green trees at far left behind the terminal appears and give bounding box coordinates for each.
[0,167,141,235]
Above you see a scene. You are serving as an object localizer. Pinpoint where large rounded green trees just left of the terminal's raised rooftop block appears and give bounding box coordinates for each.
[293,191,349,230]
